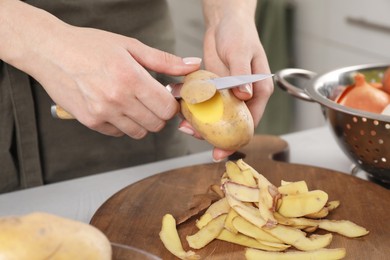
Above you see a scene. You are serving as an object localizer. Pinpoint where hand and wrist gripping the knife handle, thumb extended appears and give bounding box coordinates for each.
[0,0,201,139]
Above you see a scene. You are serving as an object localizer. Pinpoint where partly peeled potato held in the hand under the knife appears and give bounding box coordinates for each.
[180,70,254,151]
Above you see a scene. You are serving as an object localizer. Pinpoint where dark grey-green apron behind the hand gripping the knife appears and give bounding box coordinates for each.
[0,0,187,192]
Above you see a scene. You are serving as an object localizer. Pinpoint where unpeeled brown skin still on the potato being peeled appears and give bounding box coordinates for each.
[181,71,254,151]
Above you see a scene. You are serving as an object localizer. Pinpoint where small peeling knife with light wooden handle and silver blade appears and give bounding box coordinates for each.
[51,74,274,119]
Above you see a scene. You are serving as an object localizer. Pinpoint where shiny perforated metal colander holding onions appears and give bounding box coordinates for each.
[275,64,390,187]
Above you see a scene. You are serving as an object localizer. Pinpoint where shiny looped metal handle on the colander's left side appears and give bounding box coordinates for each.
[275,68,317,102]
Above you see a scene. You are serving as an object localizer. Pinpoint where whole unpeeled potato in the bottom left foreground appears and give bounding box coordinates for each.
[0,212,112,260]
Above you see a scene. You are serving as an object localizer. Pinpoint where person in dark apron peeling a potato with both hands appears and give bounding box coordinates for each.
[0,0,273,191]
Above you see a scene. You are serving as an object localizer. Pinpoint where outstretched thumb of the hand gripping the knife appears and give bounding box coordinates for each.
[127,41,202,76]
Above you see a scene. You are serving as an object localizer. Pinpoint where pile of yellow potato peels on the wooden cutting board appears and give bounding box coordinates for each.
[160,159,369,260]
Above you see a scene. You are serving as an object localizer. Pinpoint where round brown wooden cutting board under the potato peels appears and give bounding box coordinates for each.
[91,135,390,260]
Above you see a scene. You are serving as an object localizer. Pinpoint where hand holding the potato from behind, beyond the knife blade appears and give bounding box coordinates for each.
[181,0,273,161]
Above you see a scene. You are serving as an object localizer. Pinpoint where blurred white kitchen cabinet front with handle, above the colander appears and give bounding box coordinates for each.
[294,0,390,72]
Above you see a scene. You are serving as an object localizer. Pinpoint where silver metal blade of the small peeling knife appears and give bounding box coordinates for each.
[166,74,274,99]
